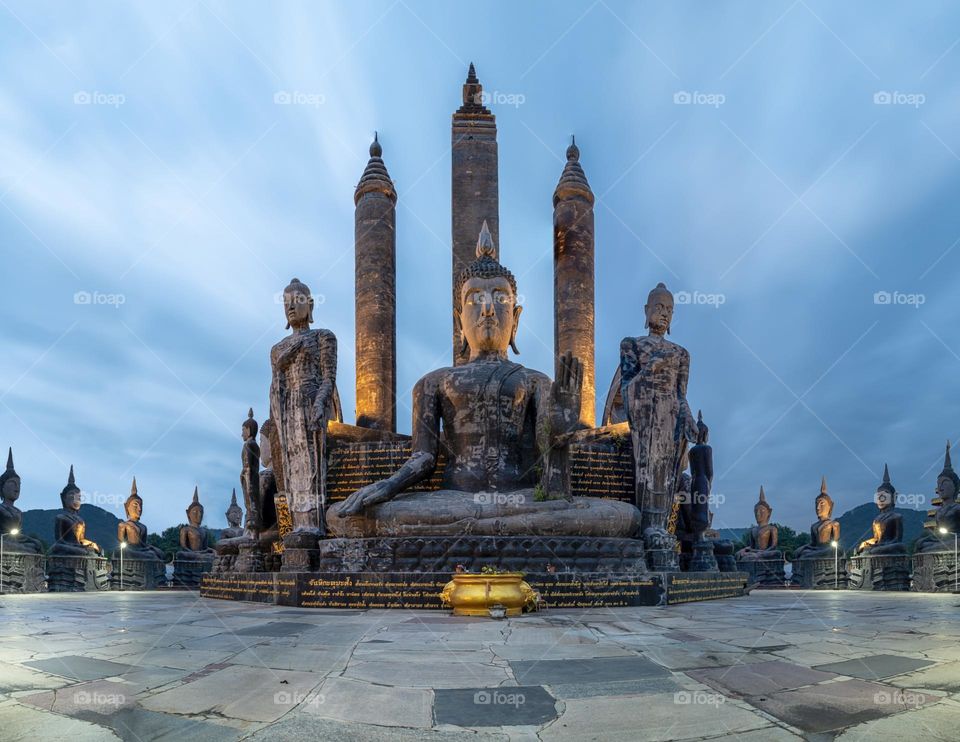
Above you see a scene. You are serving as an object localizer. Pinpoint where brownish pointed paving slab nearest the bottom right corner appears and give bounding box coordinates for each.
[748,680,935,732]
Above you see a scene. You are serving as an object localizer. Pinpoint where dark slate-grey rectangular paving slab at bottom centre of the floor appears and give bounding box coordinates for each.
[434,685,557,727]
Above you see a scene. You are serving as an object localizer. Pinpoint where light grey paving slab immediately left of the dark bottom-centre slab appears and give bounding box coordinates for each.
[300,678,433,729]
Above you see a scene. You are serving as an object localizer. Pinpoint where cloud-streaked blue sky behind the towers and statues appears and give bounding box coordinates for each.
[0,0,960,531]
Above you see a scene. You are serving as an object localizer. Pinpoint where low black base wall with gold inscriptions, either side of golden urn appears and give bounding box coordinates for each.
[200,572,747,609]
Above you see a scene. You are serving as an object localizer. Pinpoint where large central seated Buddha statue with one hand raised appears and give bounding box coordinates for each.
[327,224,640,538]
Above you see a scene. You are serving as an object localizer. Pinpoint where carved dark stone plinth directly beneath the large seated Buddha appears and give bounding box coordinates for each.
[312,536,647,575]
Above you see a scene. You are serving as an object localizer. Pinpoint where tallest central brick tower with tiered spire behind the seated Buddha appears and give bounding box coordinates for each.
[450,62,500,366]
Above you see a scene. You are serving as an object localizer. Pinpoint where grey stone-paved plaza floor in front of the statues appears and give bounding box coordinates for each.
[0,591,960,742]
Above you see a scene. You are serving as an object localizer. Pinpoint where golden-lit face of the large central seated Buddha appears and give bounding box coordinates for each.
[460,276,522,353]
